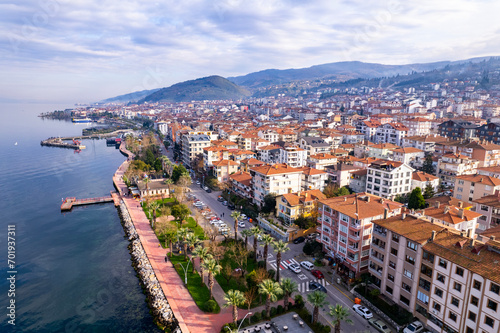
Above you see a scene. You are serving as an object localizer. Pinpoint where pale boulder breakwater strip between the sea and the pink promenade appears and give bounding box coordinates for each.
[120,201,181,333]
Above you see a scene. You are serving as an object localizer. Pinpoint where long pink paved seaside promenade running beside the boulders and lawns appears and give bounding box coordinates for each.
[113,157,252,333]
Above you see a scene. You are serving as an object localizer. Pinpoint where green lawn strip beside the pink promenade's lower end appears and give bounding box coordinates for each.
[170,255,220,313]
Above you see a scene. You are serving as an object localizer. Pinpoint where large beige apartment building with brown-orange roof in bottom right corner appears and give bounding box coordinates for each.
[370,214,500,333]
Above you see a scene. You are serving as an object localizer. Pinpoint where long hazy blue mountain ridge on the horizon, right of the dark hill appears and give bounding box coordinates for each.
[228,57,489,89]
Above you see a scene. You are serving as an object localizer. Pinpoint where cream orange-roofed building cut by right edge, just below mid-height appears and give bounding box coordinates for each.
[453,174,500,202]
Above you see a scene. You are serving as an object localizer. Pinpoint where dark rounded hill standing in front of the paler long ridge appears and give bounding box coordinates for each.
[138,75,250,103]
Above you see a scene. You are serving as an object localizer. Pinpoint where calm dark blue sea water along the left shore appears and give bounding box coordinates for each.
[0,105,159,332]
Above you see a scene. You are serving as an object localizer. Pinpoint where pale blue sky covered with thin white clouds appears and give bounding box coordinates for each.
[0,0,500,103]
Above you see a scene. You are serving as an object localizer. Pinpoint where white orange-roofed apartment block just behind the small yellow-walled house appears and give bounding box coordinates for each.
[250,164,302,206]
